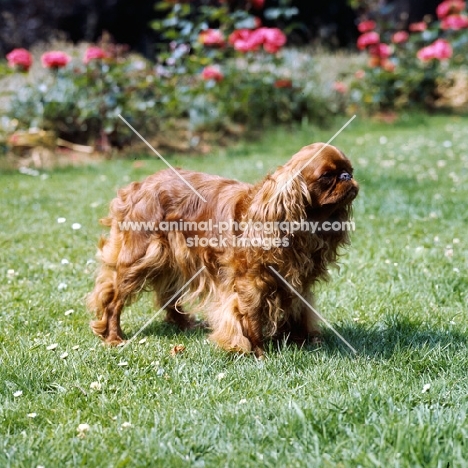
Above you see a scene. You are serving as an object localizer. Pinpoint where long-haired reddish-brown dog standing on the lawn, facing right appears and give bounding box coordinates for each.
[88,143,359,356]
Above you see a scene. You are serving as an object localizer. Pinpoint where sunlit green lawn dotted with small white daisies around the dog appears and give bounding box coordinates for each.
[0,116,468,468]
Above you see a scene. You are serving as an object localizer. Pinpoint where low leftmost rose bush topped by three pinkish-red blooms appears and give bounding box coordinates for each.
[7,47,163,149]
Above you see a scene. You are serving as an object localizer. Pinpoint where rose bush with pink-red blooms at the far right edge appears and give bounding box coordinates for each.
[348,0,468,112]
